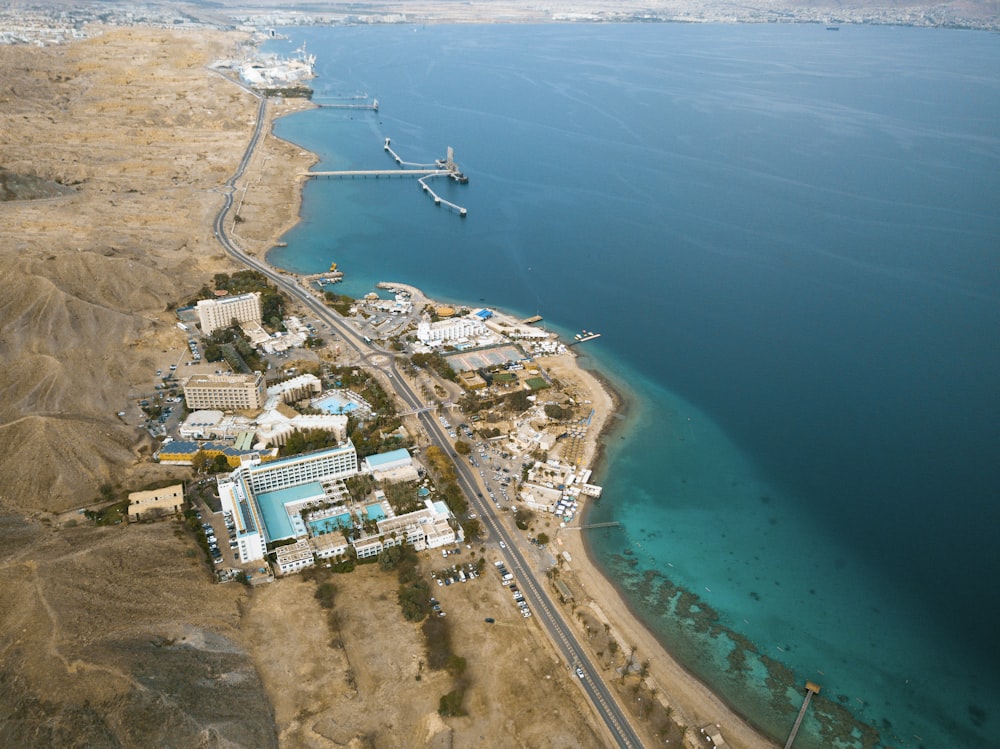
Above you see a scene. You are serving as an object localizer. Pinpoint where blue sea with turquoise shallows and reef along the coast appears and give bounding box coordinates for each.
[268,24,1000,748]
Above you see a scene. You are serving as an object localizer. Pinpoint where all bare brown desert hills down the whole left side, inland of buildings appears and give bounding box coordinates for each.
[0,29,308,749]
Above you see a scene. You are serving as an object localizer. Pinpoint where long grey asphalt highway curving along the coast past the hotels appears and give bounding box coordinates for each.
[214,97,642,749]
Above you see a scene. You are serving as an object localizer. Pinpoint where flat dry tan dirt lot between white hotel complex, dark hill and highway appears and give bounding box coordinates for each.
[243,550,605,749]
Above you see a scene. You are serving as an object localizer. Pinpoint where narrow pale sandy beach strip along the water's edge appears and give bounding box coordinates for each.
[252,82,778,749]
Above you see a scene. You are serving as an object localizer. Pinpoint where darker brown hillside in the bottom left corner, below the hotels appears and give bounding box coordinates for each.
[0,515,277,749]
